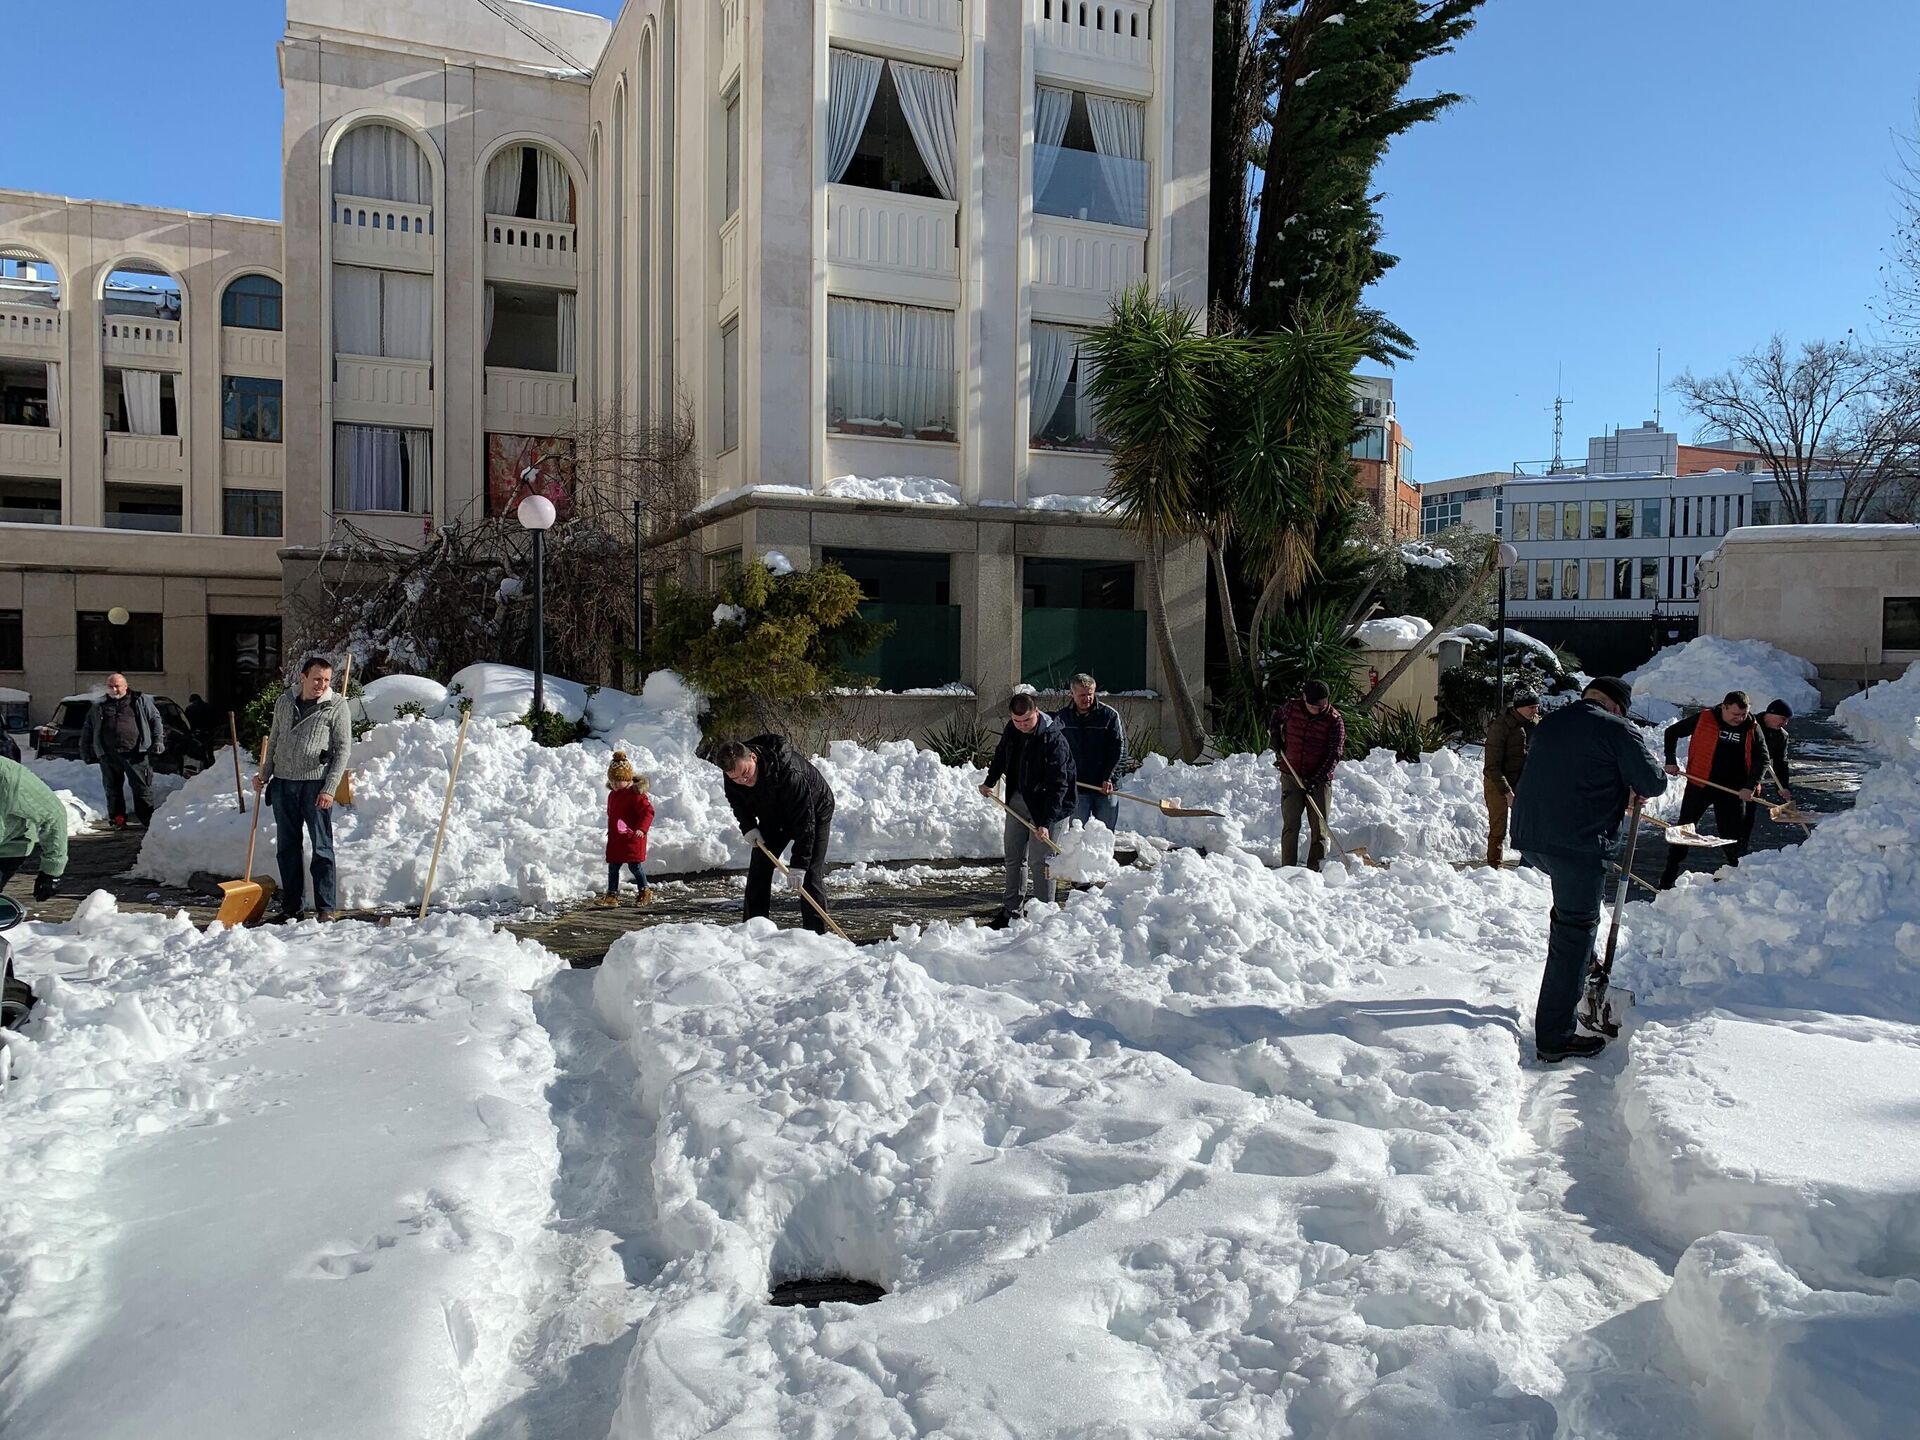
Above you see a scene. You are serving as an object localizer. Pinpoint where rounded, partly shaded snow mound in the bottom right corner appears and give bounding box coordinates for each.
[1661,1233,1920,1440]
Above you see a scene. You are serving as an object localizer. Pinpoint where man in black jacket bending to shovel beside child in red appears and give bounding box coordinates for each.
[714,735,833,935]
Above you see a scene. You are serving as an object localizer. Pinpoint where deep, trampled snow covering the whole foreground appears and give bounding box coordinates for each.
[0,676,1920,1440]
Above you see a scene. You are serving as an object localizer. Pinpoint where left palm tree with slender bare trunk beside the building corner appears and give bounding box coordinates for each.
[1083,284,1219,756]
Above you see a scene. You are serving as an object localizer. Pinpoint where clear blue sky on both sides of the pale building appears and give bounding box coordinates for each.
[0,0,1920,480]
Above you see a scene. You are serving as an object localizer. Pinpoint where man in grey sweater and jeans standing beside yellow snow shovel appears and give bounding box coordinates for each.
[253,655,353,922]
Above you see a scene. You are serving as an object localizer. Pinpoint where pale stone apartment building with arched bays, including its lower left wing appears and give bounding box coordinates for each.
[0,0,1212,737]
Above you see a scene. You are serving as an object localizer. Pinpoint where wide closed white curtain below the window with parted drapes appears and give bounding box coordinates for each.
[828,300,954,436]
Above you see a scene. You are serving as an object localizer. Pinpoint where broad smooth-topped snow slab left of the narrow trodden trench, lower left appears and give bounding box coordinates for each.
[0,906,557,1440]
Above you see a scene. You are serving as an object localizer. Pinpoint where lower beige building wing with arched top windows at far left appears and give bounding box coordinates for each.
[0,190,286,720]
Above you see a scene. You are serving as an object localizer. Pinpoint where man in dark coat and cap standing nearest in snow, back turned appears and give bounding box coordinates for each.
[1513,676,1667,1064]
